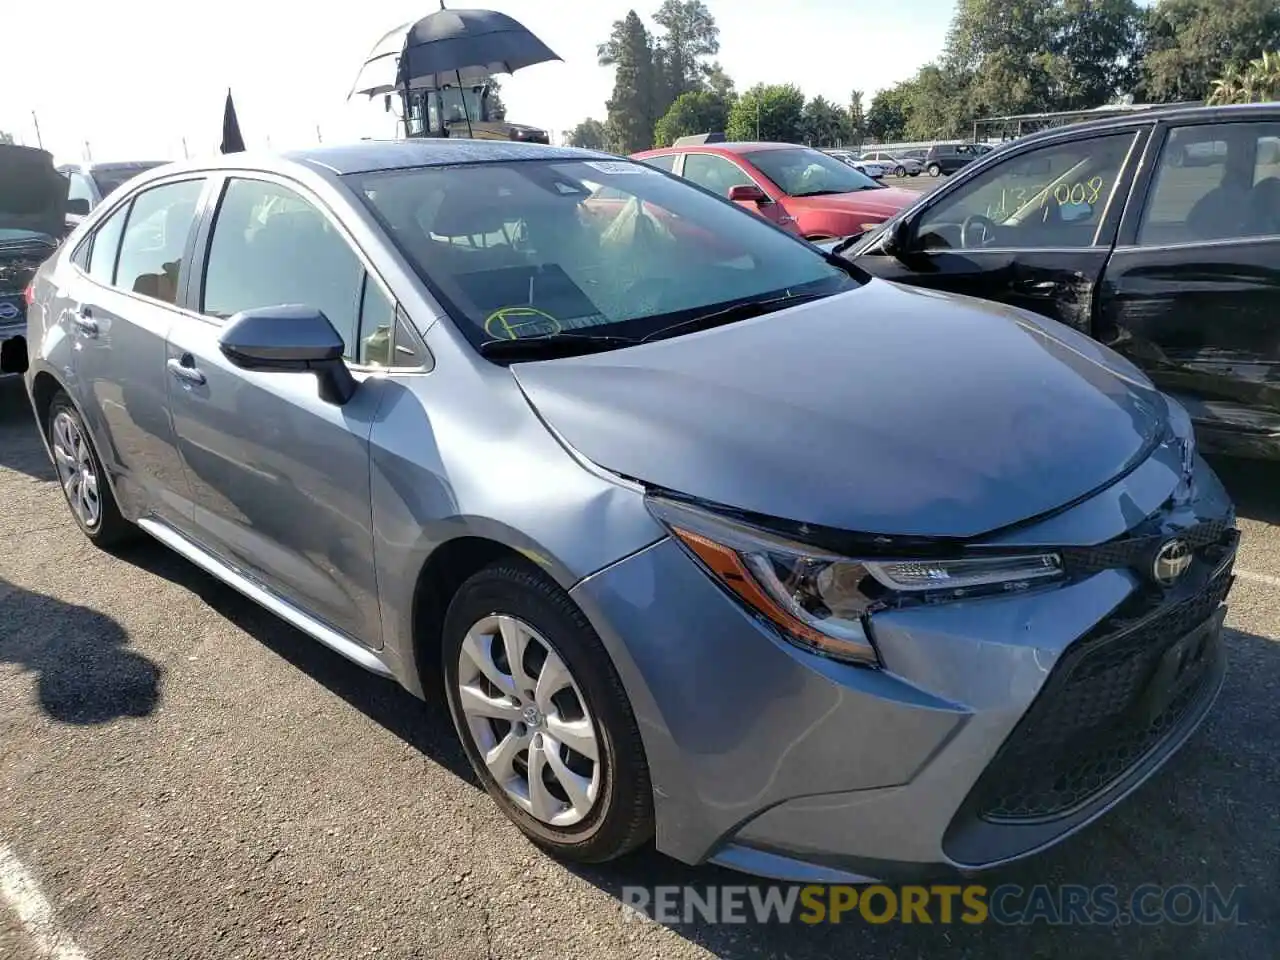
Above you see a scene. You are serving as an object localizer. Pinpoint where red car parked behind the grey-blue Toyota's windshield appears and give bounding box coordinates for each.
[632,143,919,241]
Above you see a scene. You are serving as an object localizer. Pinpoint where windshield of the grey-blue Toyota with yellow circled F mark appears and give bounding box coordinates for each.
[352,160,858,346]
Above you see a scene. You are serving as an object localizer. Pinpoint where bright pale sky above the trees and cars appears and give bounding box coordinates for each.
[0,0,955,161]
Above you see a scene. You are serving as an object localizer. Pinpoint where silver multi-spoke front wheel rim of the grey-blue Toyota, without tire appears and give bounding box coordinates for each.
[457,614,602,827]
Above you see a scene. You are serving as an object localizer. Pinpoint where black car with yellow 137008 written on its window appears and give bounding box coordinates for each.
[836,104,1280,458]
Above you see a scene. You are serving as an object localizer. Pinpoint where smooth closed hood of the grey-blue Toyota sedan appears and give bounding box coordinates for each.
[512,280,1167,538]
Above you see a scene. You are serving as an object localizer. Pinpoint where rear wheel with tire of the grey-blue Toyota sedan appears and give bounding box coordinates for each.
[49,392,136,547]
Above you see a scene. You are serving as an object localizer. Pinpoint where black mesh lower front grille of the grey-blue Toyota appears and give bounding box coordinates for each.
[970,547,1235,823]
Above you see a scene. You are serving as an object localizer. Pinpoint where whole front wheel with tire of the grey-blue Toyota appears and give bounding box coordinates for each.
[443,562,653,863]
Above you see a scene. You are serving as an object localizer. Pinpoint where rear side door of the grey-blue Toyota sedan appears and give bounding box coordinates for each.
[67,178,206,529]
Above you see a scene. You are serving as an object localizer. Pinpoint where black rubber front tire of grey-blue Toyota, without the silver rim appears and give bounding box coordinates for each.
[442,561,653,863]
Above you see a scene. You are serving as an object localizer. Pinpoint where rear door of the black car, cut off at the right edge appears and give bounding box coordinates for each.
[1097,119,1280,447]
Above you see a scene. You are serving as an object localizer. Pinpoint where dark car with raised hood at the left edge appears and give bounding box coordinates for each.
[0,143,68,374]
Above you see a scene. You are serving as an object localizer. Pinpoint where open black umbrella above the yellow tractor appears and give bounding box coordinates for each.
[351,0,561,136]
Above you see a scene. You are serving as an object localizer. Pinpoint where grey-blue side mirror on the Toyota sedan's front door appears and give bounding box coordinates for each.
[218,303,357,406]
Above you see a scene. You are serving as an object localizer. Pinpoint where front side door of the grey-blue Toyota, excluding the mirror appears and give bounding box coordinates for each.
[168,175,419,648]
